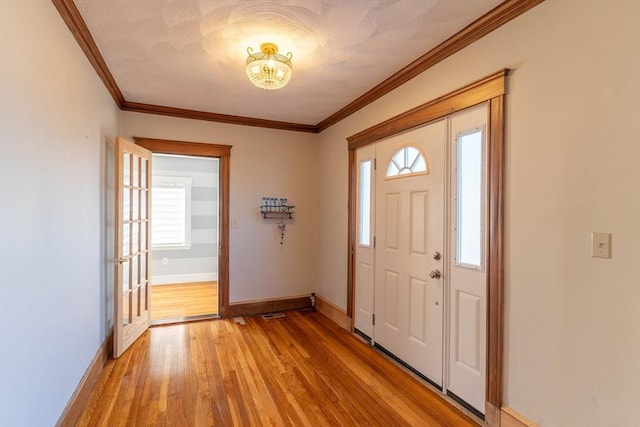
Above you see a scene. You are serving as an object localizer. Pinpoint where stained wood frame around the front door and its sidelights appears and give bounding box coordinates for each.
[347,68,510,426]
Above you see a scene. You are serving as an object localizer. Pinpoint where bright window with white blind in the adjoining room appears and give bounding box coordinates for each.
[151,176,191,249]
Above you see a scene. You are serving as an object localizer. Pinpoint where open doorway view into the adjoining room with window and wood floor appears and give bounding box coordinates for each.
[151,153,220,324]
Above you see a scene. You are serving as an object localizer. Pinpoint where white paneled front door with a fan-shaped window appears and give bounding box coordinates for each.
[376,120,446,385]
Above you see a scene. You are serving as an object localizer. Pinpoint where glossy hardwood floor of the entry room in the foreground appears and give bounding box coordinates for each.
[77,312,478,427]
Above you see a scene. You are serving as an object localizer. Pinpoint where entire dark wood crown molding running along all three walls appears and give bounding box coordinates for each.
[51,0,544,133]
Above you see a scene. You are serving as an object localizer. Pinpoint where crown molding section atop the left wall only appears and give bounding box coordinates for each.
[51,0,125,108]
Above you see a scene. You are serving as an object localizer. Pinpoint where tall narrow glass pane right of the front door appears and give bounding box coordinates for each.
[456,129,484,269]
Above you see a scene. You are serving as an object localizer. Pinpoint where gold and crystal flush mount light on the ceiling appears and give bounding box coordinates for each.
[247,43,293,90]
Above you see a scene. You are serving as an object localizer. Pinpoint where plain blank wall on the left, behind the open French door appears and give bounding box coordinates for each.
[0,0,117,427]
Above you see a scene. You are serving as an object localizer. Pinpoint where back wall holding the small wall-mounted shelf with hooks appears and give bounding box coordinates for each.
[120,112,320,302]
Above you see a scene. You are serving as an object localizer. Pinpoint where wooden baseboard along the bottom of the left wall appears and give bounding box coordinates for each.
[56,331,113,427]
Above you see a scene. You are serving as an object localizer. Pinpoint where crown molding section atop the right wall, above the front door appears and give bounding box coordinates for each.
[317,0,544,132]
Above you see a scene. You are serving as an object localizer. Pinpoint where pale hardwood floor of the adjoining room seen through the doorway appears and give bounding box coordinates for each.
[151,282,218,321]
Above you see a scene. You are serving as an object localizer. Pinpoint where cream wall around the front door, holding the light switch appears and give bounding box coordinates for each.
[319,0,640,427]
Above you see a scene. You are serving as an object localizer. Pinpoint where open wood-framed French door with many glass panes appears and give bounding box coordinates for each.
[113,138,151,357]
